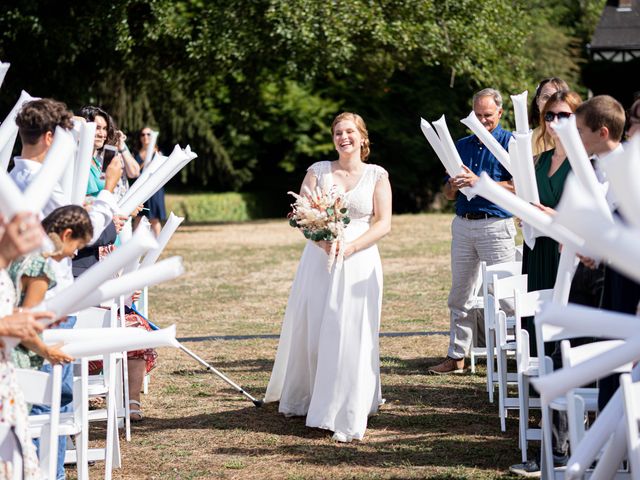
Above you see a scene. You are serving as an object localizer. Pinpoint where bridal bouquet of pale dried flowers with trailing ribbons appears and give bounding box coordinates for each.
[287,187,351,271]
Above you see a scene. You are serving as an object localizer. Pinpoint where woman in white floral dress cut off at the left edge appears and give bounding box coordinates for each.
[0,213,51,480]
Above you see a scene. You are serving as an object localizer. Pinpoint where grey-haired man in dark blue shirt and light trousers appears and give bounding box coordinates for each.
[429,88,516,374]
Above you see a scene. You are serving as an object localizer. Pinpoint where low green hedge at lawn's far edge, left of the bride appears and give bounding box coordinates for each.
[165,192,282,223]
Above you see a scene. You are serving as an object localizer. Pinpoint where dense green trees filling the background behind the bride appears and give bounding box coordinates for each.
[0,0,604,211]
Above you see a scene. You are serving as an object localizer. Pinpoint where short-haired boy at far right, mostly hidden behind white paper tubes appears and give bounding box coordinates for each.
[576,95,640,410]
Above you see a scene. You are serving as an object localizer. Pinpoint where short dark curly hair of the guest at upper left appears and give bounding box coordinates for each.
[16,98,73,145]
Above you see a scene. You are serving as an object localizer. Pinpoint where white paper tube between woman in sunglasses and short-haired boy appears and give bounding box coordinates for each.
[553,115,611,218]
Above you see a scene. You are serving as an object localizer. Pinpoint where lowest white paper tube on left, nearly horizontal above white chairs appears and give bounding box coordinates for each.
[61,325,180,358]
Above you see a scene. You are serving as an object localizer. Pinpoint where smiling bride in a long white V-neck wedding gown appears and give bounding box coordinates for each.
[265,112,391,442]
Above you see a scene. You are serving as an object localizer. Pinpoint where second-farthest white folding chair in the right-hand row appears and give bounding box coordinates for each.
[493,274,527,432]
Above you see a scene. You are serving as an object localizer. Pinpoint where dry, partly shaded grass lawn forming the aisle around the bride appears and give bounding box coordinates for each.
[100,215,520,480]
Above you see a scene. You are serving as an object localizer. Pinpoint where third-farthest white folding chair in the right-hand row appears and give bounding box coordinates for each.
[514,289,553,463]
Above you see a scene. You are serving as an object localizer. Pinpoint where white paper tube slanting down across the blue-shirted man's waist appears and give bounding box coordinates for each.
[471,172,585,249]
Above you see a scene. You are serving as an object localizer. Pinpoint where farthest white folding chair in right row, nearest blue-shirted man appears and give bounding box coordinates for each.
[470,262,522,403]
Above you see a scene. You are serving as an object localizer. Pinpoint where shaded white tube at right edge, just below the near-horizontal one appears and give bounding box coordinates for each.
[531,330,640,405]
